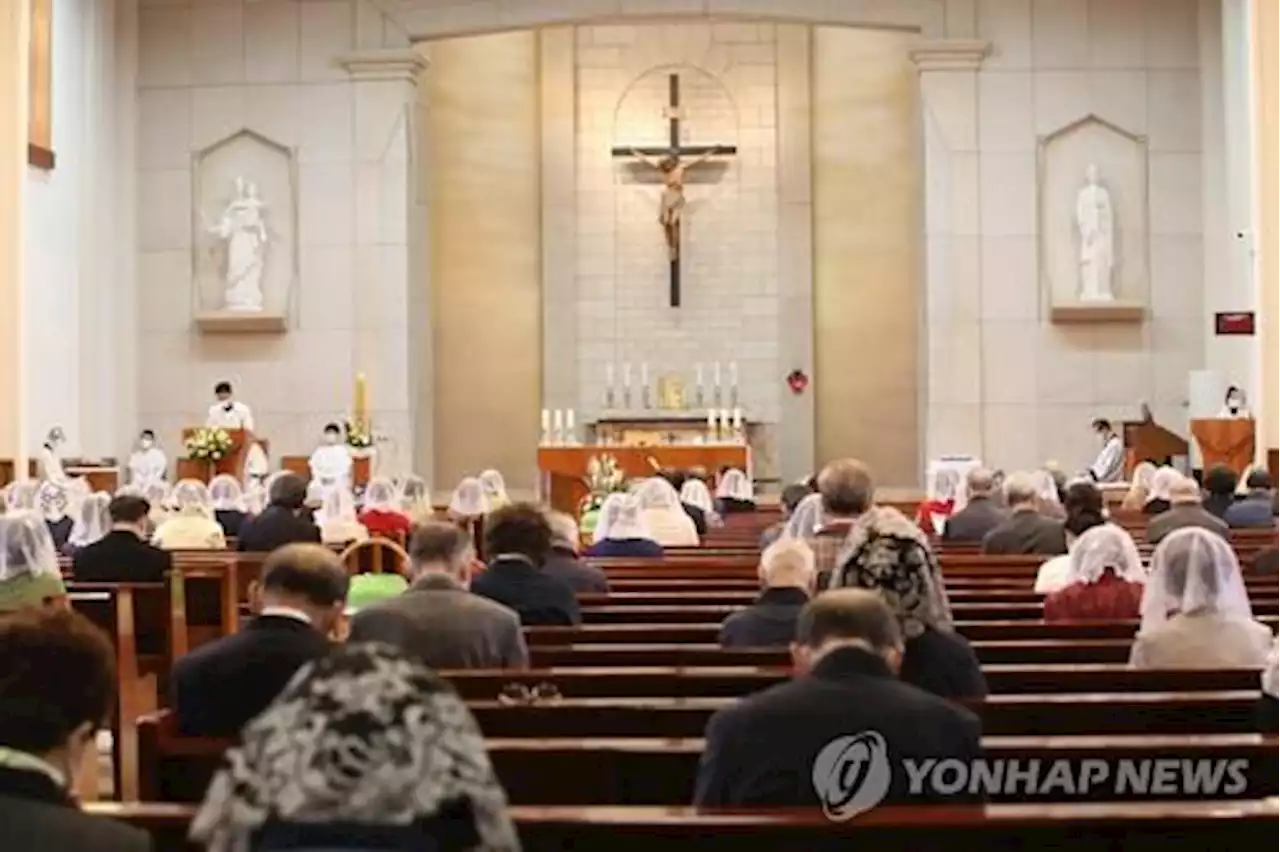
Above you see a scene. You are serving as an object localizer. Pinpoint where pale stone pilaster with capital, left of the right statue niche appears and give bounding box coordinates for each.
[911,38,993,458]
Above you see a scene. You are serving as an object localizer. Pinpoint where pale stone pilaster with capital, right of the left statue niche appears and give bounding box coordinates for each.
[339,47,431,481]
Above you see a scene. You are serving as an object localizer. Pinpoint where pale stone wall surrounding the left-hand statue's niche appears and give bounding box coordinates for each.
[137,0,412,466]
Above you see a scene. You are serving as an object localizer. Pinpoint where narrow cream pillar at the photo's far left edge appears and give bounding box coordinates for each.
[0,3,29,465]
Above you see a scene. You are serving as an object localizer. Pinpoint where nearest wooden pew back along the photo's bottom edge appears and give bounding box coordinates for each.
[86,798,1280,852]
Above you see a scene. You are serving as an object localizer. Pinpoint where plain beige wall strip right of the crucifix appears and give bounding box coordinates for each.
[813,27,922,485]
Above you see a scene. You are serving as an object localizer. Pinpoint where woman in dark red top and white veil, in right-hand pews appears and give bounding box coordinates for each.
[1044,523,1147,622]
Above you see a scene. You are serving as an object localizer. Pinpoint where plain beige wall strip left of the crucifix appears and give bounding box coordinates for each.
[425,32,543,491]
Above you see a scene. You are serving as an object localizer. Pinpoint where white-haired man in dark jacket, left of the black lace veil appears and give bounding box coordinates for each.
[721,539,818,647]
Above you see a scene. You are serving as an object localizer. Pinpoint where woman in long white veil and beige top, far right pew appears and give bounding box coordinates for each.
[1129,527,1271,669]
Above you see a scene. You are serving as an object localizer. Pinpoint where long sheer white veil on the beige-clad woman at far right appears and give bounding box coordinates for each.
[1142,527,1253,631]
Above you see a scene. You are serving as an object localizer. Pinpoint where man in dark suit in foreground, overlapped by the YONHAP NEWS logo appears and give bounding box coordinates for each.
[694,588,982,807]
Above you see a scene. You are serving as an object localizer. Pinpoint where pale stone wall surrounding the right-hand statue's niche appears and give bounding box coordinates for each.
[925,0,1203,469]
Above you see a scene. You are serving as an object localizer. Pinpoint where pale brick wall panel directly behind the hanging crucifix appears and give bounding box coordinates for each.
[573,23,786,424]
